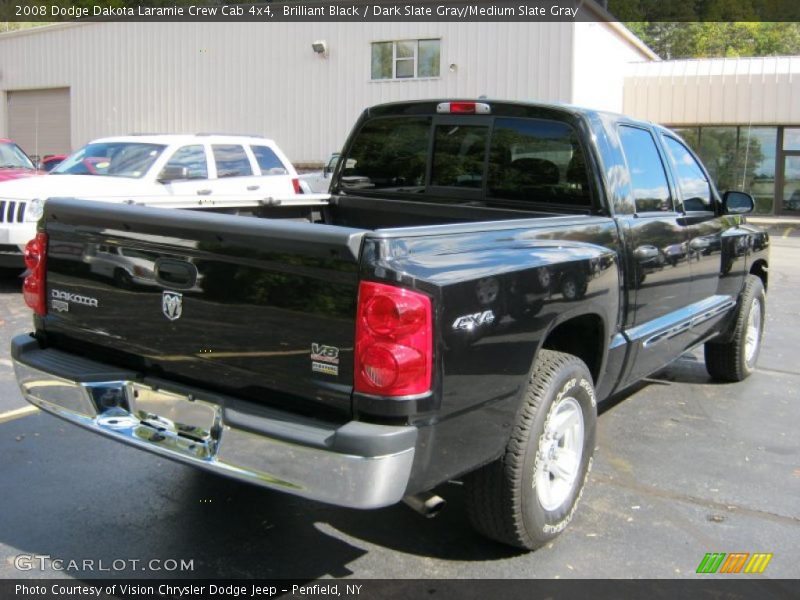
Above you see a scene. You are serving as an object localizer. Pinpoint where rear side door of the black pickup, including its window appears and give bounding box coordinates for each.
[618,125,691,381]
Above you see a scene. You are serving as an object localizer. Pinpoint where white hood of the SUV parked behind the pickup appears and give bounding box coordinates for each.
[0,175,153,200]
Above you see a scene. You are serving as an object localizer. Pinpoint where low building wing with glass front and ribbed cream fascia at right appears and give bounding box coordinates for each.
[623,56,800,216]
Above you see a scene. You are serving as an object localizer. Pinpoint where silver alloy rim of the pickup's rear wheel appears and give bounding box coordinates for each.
[533,396,584,511]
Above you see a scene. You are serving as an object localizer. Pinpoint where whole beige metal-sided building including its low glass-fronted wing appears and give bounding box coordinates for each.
[0,18,800,215]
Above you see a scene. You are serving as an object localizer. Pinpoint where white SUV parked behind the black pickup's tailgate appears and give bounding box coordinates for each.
[0,134,300,267]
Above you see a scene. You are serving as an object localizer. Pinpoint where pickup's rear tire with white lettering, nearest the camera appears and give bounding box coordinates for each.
[465,350,597,550]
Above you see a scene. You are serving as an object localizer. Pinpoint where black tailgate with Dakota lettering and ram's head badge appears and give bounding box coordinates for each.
[42,199,365,417]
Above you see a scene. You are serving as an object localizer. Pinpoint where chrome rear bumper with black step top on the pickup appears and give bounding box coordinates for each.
[11,335,417,508]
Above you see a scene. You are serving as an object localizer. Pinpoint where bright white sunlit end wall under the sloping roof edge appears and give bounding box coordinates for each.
[572,22,655,112]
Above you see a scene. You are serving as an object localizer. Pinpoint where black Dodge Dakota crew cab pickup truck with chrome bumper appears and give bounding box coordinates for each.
[11,100,769,549]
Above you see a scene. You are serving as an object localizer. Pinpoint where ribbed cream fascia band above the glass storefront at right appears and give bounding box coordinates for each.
[623,56,800,125]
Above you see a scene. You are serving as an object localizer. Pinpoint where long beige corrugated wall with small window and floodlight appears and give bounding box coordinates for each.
[0,22,574,163]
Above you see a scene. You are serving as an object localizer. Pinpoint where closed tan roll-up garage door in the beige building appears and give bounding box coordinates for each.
[7,88,71,156]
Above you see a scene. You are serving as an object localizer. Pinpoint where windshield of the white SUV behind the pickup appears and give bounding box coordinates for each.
[51,142,166,179]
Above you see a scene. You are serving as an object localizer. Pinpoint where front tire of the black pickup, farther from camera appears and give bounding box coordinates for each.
[704,275,767,381]
